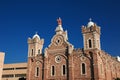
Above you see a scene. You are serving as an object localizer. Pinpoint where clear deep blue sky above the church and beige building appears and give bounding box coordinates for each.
[0,0,120,63]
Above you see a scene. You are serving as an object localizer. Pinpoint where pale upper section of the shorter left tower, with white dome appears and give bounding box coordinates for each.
[28,33,44,57]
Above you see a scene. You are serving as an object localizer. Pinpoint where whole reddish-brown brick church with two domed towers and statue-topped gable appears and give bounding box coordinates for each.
[27,18,120,80]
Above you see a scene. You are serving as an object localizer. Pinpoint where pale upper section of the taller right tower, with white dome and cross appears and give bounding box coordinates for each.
[82,19,101,50]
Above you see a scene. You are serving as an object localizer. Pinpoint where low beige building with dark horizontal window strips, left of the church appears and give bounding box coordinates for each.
[2,63,27,80]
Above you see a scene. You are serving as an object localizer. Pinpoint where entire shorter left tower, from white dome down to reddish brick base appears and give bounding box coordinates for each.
[27,33,44,80]
